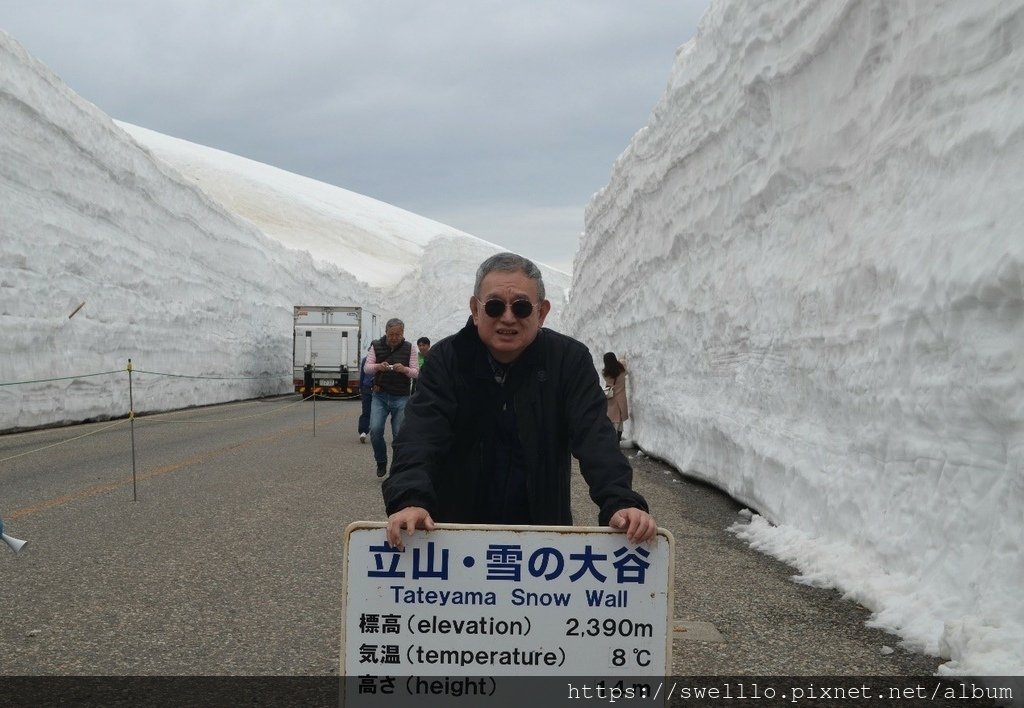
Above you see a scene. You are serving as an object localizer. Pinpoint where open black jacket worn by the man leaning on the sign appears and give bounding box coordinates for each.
[383,322,647,526]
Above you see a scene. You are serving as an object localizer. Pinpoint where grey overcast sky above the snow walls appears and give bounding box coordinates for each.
[0,0,709,270]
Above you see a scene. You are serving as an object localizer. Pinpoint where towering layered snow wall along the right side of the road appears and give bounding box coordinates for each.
[564,0,1024,674]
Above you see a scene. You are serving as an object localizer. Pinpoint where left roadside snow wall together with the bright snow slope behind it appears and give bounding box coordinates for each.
[0,31,568,430]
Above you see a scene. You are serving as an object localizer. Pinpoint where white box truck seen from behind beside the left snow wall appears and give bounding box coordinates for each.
[292,305,384,398]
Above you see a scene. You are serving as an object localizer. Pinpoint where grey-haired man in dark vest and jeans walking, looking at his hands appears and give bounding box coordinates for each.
[362,318,420,477]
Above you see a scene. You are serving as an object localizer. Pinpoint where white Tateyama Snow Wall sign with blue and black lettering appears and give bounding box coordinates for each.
[341,522,675,695]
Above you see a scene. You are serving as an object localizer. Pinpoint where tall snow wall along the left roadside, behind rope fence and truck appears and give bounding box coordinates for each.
[0,32,379,430]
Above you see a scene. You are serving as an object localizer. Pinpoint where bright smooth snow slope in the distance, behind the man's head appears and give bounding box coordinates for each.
[120,123,569,352]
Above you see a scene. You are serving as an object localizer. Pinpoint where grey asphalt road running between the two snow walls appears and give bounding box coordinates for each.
[0,397,939,676]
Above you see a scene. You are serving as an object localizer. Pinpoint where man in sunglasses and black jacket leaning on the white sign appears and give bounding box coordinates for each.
[383,253,657,548]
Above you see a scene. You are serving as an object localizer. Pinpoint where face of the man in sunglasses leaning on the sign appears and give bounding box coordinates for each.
[469,270,551,364]
